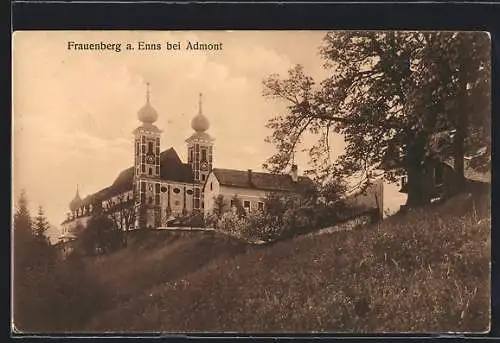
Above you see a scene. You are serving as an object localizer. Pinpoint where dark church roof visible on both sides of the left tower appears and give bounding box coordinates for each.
[83,148,193,205]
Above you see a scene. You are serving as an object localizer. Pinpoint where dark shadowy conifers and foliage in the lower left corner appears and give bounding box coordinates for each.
[12,192,106,333]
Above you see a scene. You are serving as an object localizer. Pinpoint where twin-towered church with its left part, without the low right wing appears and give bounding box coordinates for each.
[62,87,214,235]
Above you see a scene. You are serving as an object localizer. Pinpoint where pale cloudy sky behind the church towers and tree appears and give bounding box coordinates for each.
[12,31,404,242]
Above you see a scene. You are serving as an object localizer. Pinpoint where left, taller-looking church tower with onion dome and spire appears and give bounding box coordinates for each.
[133,83,162,228]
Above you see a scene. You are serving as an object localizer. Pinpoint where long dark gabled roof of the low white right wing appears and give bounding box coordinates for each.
[212,168,314,192]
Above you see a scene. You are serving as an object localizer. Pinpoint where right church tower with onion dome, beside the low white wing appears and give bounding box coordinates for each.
[186,93,214,211]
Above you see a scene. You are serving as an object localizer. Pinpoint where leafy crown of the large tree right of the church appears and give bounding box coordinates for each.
[264,31,490,205]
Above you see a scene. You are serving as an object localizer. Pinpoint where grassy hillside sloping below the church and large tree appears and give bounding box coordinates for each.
[82,197,491,332]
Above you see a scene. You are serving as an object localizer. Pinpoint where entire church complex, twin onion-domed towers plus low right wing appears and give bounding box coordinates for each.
[61,85,313,237]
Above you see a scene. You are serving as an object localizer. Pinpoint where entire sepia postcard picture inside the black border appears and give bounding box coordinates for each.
[11,30,492,335]
